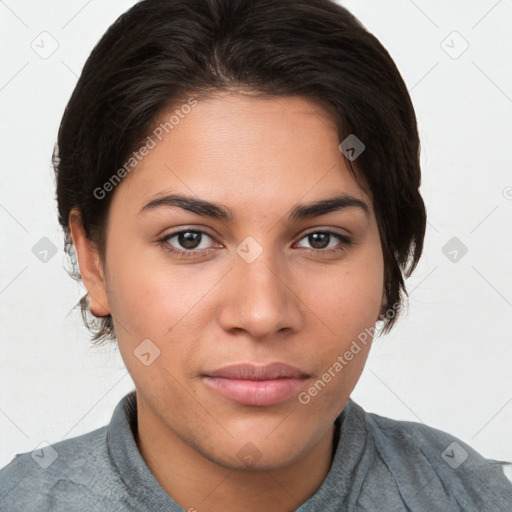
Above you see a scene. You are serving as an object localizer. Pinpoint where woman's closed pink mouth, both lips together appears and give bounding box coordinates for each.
[202,363,310,407]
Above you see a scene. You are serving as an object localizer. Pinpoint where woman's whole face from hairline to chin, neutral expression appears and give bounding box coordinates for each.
[82,94,384,468]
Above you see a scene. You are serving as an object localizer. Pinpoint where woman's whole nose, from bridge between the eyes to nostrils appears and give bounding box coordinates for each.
[221,239,300,338]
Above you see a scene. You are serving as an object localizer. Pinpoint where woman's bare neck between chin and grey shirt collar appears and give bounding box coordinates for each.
[137,404,335,512]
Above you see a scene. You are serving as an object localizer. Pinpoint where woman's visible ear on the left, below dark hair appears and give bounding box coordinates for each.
[69,208,110,317]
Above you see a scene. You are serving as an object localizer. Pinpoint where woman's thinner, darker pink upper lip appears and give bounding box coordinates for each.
[204,363,309,380]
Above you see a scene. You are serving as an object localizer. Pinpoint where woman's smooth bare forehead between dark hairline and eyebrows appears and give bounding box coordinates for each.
[112,93,371,217]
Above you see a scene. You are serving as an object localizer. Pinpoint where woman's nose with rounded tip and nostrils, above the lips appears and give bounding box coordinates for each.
[217,250,303,340]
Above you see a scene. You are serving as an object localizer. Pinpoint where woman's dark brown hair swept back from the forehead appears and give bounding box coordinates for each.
[53,0,426,342]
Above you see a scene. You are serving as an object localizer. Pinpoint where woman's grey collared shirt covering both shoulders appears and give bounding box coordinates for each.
[0,391,512,512]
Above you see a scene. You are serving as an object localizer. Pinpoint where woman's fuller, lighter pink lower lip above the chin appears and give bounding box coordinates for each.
[203,377,306,406]
